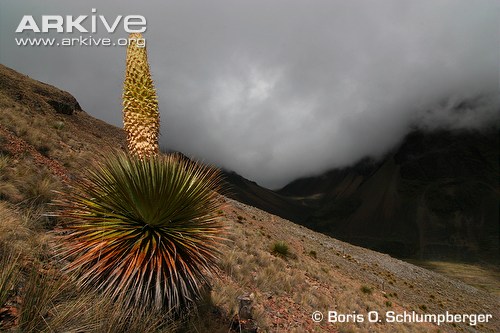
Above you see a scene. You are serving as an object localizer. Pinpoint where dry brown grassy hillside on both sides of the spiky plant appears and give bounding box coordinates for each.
[0,66,500,333]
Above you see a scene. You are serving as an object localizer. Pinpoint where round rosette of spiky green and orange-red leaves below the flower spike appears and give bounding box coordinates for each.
[54,154,224,312]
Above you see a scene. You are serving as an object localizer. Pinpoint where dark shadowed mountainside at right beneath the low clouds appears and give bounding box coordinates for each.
[280,128,500,259]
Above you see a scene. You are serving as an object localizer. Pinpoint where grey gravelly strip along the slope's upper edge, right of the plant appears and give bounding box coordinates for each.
[226,199,500,332]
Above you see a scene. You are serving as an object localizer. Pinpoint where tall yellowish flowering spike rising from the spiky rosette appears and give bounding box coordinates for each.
[123,33,160,158]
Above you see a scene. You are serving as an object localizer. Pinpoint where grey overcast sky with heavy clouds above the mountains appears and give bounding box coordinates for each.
[0,0,500,188]
